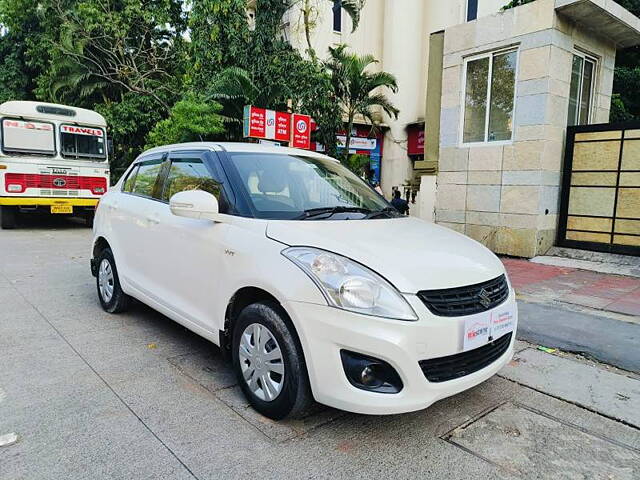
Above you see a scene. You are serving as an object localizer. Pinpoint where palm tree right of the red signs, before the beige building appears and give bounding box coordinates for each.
[325,45,399,162]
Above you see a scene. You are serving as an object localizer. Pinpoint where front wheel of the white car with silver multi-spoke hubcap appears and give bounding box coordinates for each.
[232,302,313,420]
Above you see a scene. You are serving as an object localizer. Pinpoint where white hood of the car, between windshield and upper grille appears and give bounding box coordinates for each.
[267,217,504,293]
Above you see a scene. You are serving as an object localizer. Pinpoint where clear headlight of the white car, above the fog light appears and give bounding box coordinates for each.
[282,247,418,320]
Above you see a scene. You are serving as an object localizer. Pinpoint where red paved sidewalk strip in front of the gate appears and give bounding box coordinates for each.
[502,258,640,320]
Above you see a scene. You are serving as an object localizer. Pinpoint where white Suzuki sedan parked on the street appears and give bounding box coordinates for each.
[91,143,517,419]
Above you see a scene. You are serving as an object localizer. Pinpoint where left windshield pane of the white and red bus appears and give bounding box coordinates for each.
[2,118,56,155]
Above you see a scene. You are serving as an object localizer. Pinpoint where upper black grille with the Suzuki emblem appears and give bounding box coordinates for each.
[418,275,509,317]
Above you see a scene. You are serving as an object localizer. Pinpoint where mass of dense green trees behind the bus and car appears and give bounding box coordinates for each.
[0,0,378,179]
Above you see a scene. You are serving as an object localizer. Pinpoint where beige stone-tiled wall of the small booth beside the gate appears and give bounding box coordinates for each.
[436,0,615,257]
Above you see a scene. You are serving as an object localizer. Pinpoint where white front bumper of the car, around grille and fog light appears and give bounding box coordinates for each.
[284,290,517,415]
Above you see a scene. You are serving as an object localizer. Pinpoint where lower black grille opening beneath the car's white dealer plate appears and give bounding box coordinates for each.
[418,333,512,383]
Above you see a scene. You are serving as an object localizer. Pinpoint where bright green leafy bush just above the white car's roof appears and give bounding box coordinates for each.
[147,94,224,148]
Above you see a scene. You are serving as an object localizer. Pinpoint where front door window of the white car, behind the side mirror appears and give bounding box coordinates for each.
[162,158,220,202]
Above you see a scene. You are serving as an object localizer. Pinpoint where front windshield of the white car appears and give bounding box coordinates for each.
[230,153,390,219]
